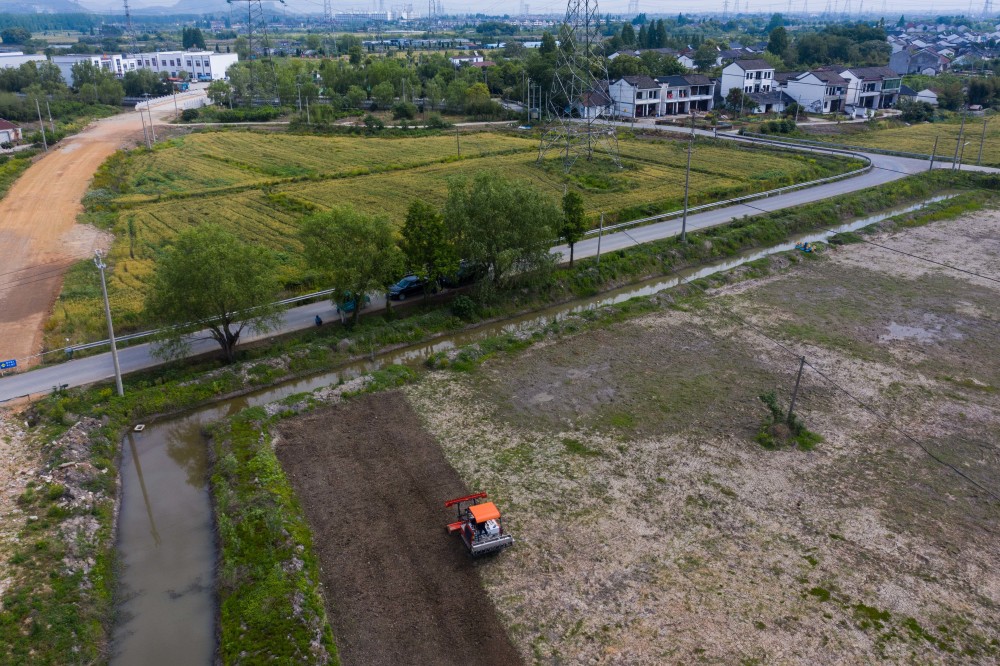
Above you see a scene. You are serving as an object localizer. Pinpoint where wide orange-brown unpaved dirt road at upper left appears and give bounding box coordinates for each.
[0,100,197,365]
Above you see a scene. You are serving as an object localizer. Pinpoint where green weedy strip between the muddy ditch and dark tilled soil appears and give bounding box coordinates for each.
[211,407,339,664]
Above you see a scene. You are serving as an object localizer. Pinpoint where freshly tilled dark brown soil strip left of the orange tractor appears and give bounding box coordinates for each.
[275,392,520,665]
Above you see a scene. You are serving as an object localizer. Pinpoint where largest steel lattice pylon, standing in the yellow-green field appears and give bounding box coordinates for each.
[538,0,621,170]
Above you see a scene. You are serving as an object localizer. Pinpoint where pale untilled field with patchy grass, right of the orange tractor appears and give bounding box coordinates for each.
[406,211,1000,664]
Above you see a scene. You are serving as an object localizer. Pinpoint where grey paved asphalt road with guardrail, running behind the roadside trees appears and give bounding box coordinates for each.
[0,129,1000,403]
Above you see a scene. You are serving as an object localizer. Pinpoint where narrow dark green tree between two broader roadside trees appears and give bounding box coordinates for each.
[399,199,458,300]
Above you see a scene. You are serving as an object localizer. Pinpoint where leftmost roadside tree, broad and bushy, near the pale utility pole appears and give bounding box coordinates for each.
[146,224,280,363]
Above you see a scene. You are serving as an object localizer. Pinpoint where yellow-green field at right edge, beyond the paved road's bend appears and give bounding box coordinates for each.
[807,115,1000,166]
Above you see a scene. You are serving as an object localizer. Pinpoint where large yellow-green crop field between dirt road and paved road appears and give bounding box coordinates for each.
[47,131,858,347]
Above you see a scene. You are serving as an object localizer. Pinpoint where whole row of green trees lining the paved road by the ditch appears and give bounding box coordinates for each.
[146,173,585,362]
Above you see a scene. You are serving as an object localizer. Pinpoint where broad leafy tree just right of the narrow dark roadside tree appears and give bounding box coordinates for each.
[444,171,562,288]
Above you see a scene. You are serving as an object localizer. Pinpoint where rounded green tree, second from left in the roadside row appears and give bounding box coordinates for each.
[300,207,403,323]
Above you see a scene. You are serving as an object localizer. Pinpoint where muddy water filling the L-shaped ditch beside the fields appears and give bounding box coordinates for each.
[112,196,949,666]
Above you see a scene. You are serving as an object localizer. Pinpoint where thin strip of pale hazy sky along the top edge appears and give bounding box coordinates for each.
[74,0,988,22]
